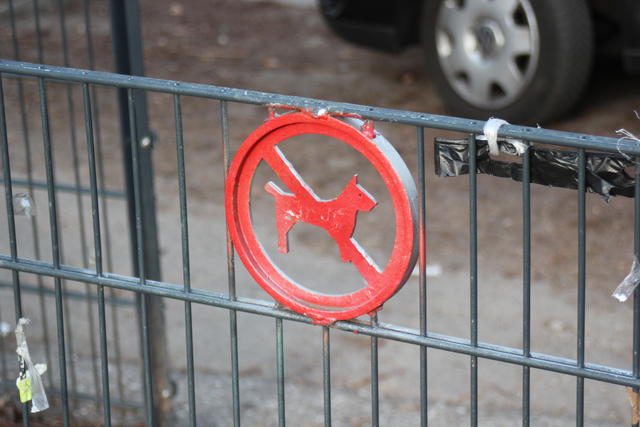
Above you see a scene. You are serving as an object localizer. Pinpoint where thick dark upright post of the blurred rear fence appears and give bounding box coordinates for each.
[109,0,171,426]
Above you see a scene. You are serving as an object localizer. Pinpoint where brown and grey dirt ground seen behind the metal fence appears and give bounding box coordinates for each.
[0,0,640,426]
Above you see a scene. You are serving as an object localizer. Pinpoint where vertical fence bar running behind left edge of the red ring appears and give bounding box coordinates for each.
[220,101,240,427]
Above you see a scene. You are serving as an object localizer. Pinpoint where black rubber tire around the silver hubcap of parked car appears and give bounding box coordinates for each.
[421,0,594,125]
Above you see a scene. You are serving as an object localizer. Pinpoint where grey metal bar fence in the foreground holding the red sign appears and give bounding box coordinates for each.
[0,60,640,425]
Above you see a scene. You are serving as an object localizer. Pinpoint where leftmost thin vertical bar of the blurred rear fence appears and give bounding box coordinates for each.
[9,0,52,392]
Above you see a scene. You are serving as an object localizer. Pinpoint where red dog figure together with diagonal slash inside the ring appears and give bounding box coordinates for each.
[263,146,381,283]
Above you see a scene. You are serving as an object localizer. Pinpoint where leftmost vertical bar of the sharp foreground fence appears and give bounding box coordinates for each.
[0,74,29,426]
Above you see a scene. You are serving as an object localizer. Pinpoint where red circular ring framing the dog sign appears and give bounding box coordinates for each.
[225,113,417,323]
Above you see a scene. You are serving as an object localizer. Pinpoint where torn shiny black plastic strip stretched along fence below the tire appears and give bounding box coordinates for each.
[434,138,635,199]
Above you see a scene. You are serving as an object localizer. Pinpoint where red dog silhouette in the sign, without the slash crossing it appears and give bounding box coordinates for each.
[264,175,377,262]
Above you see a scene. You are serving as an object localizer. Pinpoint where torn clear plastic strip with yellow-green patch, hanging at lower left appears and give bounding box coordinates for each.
[15,318,49,413]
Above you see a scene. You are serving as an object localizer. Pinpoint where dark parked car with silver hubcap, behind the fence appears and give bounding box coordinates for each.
[319,0,640,124]
